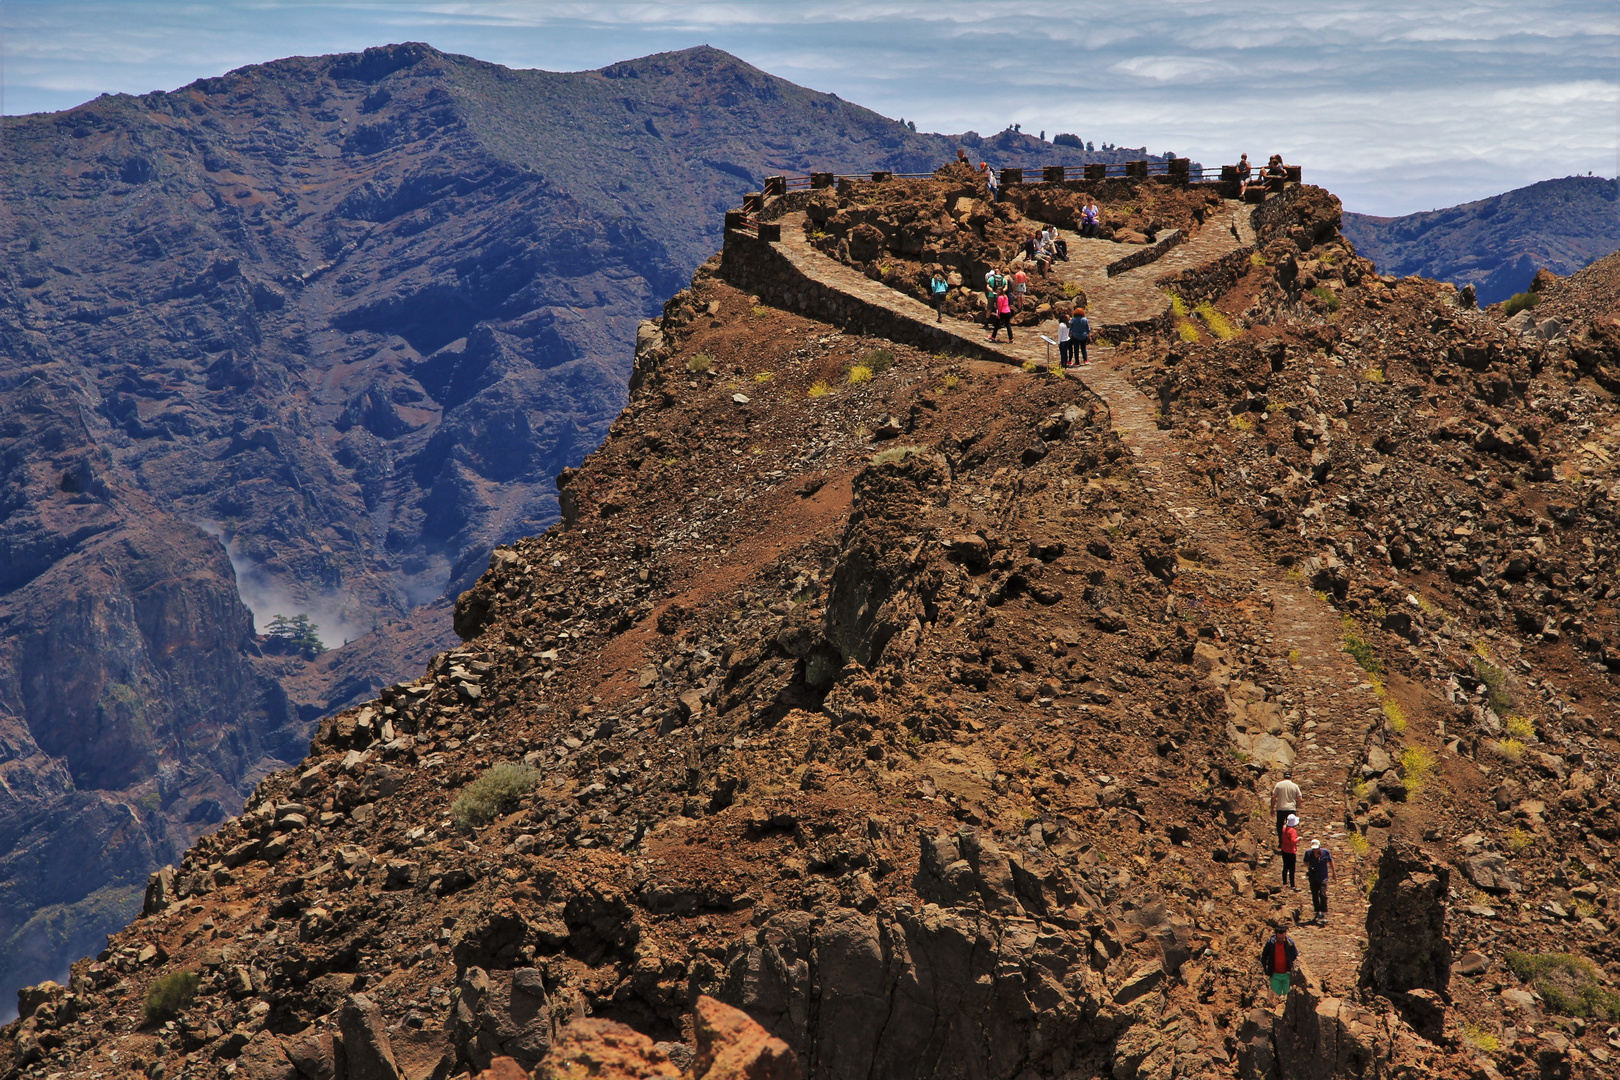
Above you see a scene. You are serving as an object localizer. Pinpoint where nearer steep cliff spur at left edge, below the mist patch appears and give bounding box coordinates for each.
[0,366,305,1003]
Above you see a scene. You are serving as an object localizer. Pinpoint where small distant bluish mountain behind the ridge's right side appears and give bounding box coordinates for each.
[1341,176,1620,304]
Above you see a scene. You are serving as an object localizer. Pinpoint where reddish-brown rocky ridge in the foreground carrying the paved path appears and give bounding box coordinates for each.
[0,170,1620,1080]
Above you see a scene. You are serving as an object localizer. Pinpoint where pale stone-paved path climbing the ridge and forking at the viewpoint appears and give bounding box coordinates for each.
[764,204,1380,994]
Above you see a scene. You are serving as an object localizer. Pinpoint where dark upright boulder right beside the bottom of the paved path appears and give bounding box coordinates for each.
[1361,842,1452,997]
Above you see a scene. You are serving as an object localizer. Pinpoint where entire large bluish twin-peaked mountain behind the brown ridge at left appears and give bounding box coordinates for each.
[0,45,1114,1016]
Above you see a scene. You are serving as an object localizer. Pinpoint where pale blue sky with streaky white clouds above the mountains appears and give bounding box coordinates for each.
[0,0,1620,214]
